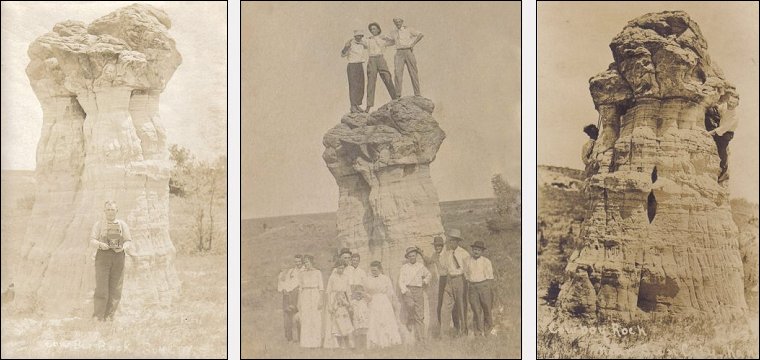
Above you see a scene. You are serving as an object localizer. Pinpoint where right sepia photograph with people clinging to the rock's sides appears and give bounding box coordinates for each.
[536,1,760,359]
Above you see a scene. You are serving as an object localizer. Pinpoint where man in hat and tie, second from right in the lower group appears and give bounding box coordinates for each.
[441,229,470,336]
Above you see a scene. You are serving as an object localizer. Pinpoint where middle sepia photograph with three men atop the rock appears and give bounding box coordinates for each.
[240,1,532,359]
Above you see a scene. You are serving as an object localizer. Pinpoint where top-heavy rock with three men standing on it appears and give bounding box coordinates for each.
[322,96,446,279]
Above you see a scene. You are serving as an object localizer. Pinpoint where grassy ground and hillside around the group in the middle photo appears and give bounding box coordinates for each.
[241,199,521,358]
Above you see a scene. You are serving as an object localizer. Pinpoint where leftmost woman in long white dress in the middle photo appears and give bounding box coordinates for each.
[298,255,324,348]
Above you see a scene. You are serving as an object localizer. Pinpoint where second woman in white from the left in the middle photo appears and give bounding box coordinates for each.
[323,261,354,349]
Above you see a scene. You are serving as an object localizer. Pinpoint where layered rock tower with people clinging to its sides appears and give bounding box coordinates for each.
[559,11,747,319]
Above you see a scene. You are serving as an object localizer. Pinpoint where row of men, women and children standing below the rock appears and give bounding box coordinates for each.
[277,229,494,348]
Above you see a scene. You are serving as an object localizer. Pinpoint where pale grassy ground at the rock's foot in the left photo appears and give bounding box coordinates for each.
[2,255,227,358]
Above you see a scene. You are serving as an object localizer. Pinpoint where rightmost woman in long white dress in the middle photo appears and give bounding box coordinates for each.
[364,261,401,349]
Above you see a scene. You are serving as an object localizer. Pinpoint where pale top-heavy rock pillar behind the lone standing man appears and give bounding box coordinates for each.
[14,4,182,314]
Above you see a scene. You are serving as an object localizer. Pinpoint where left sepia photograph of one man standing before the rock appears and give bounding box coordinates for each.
[0,1,228,358]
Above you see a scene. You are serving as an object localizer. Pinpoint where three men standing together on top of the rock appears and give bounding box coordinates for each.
[341,18,424,113]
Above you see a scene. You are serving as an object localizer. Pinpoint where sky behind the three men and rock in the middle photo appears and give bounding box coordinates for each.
[241,1,520,218]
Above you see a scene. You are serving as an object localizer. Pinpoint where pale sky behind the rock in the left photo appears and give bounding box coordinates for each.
[2,1,226,170]
